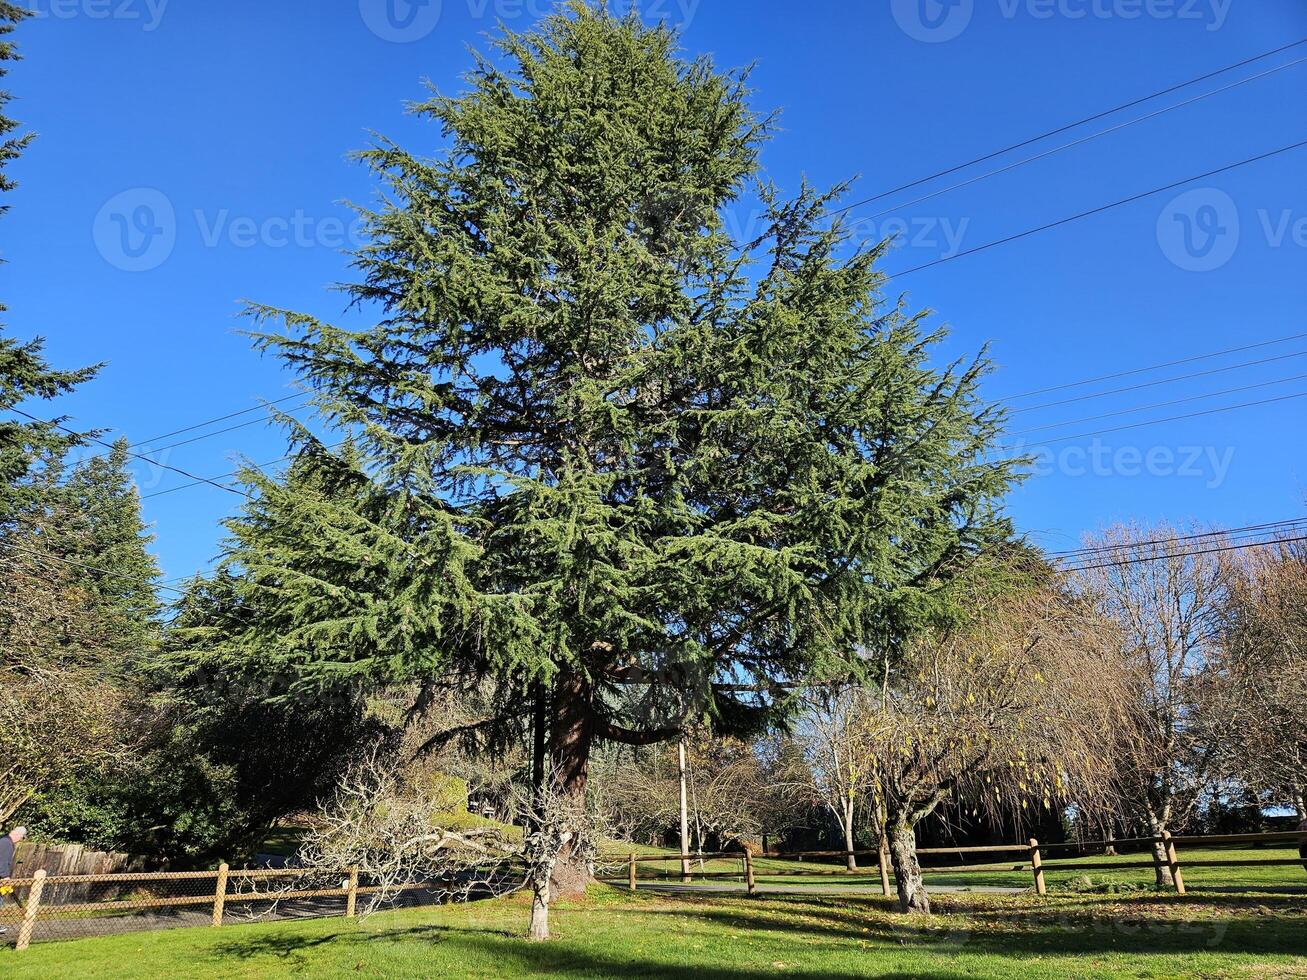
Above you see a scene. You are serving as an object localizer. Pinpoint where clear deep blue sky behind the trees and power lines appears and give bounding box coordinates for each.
[0,0,1307,576]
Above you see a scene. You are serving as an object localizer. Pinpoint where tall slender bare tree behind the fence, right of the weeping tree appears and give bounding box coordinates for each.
[1074,524,1226,886]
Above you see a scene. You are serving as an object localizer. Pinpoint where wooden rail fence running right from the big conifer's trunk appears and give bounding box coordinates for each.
[603,831,1307,895]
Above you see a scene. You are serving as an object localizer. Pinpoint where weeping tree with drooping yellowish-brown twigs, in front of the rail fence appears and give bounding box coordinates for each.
[859,559,1123,912]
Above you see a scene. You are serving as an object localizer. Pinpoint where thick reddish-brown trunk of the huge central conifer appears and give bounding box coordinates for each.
[549,668,595,899]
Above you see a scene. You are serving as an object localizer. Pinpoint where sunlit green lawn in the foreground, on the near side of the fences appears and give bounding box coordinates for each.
[0,886,1307,980]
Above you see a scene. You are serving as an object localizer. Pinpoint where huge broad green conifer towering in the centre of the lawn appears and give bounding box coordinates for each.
[206,4,1014,891]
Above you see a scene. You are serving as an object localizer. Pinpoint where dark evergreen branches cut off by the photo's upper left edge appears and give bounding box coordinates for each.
[0,0,98,525]
